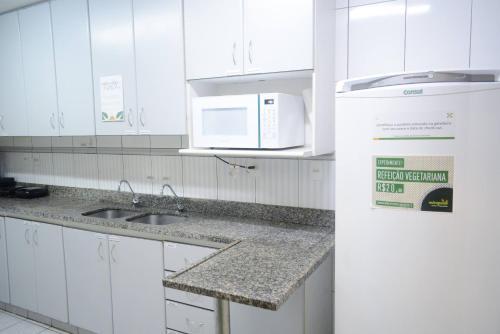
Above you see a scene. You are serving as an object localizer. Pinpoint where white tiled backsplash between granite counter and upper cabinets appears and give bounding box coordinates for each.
[0,136,335,210]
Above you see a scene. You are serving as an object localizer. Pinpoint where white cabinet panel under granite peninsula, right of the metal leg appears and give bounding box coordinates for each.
[230,286,304,334]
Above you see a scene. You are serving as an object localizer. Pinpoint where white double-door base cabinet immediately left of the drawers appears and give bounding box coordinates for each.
[64,229,166,334]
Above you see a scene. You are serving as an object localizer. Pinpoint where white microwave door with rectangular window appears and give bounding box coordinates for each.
[193,95,259,148]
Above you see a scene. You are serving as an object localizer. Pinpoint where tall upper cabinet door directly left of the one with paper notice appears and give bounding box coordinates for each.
[51,0,95,136]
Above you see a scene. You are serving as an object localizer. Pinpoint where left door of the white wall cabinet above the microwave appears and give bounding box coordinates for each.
[184,0,243,79]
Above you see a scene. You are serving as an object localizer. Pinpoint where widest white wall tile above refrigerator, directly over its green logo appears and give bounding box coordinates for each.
[406,0,472,71]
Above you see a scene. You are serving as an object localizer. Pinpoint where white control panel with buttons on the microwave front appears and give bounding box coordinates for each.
[260,97,279,148]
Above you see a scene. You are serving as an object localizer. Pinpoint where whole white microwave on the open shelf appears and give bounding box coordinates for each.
[192,93,304,149]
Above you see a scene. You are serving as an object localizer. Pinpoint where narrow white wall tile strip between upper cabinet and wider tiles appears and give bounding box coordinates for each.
[335,8,349,81]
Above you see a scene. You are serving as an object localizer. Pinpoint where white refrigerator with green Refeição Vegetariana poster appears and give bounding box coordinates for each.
[335,71,500,334]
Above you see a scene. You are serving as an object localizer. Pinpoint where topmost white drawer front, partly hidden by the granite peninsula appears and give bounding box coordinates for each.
[164,242,217,271]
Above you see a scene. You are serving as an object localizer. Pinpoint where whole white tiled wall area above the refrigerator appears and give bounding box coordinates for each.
[336,0,500,80]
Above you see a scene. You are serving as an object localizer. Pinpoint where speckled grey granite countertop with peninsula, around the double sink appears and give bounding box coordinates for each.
[0,196,334,310]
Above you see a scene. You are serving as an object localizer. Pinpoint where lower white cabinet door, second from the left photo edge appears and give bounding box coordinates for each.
[5,218,38,312]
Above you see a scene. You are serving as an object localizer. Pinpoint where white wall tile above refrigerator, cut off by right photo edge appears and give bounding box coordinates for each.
[470,0,500,69]
